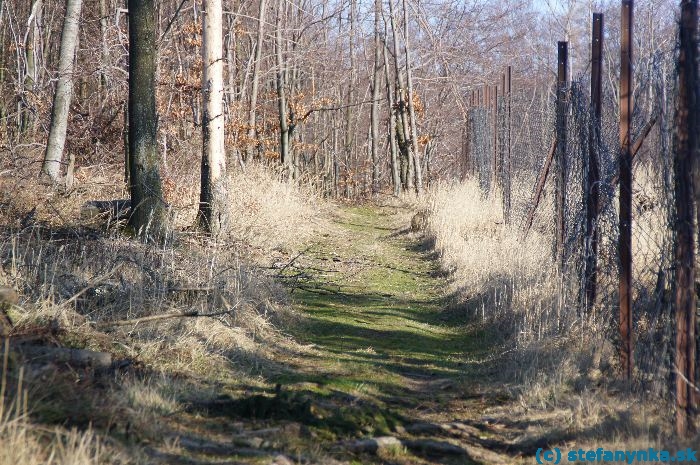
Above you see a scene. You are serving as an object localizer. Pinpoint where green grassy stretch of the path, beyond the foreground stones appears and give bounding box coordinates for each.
[284,207,481,394]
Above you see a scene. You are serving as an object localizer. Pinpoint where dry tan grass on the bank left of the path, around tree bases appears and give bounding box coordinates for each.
[0,154,326,465]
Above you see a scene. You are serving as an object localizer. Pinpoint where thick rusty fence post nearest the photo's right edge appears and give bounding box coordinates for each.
[673,0,700,436]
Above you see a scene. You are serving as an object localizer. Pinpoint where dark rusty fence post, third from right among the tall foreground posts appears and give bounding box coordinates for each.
[583,13,604,312]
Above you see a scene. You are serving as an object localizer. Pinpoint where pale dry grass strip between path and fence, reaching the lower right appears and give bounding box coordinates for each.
[424,181,696,447]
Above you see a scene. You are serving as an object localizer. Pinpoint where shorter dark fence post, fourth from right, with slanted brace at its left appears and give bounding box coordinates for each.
[554,42,569,272]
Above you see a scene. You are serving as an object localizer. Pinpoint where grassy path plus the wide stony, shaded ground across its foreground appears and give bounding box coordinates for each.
[152,206,546,465]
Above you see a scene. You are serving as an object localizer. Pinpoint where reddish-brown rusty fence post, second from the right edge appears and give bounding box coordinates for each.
[618,0,634,380]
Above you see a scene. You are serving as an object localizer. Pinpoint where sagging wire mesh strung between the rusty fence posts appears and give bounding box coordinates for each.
[466,42,676,395]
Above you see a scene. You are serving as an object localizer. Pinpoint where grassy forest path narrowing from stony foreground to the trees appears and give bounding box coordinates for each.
[275,205,516,464]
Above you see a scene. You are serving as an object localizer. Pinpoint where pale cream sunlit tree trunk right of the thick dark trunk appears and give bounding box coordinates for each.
[199,0,227,234]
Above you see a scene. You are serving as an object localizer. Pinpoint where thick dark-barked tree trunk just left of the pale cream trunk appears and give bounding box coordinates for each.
[129,0,168,241]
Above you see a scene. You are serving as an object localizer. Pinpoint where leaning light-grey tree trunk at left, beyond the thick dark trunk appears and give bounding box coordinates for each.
[42,0,83,183]
